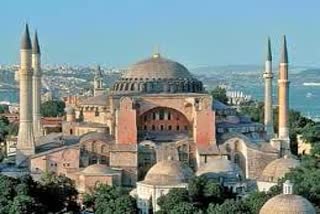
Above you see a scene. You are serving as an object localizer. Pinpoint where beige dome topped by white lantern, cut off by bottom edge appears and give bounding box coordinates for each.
[260,194,316,214]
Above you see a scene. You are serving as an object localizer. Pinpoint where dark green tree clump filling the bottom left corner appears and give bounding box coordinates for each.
[0,173,79,214]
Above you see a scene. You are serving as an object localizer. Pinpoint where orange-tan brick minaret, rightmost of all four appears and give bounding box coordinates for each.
[278,36,290,153]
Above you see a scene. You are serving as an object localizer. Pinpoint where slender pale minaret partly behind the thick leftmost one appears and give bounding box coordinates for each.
[32,32,42,141]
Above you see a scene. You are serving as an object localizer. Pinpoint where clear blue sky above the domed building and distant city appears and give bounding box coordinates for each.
[0,0,320,68]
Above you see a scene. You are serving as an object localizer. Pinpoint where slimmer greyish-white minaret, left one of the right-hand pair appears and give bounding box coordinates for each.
[263,38,273,139]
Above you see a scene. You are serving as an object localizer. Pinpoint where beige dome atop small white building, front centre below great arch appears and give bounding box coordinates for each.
[143,160,193,185]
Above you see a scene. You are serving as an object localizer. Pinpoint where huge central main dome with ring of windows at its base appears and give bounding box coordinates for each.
[112,54,203,93]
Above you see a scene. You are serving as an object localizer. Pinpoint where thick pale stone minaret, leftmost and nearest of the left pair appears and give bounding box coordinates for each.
[16,25,35,166]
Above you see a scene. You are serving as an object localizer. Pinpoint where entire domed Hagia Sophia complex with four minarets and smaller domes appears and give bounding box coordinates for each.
[2,26,315,213]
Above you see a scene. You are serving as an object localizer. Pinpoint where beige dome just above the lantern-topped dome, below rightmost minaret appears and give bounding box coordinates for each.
[259,156,300,182]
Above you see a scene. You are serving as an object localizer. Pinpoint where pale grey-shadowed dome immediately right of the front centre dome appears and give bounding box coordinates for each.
[196,158,244,182]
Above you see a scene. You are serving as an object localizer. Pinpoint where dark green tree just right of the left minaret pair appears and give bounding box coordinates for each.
[40,100,65,117]
